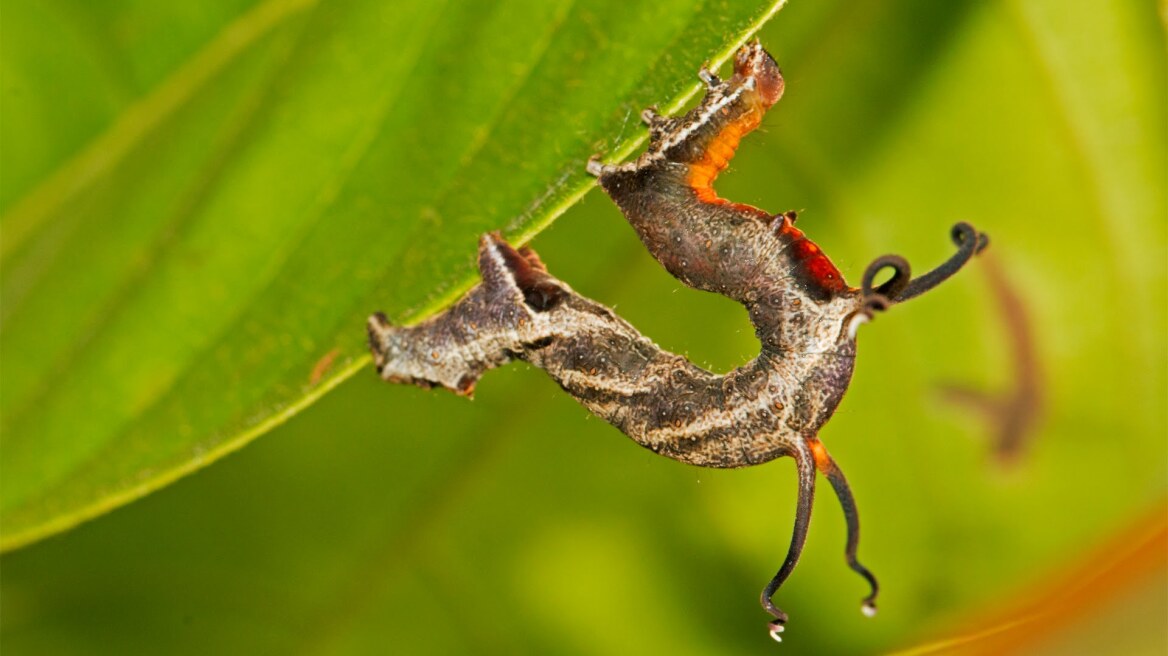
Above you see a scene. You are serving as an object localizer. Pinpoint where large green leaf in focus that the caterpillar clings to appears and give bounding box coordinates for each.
[0,0,781,550]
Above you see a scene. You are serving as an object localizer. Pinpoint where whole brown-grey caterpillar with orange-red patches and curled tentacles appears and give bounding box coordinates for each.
[368,43,985,637]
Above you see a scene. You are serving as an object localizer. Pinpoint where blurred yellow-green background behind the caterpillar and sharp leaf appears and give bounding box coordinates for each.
[0,0,1168,654]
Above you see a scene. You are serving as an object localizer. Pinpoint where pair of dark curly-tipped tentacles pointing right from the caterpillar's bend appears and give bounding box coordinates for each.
[861,222,989,312]
